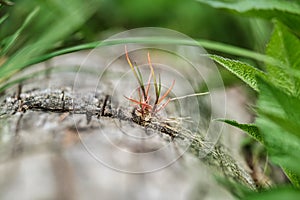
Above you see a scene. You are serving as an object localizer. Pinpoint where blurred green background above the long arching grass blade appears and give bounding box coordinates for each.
[0,0,272,91]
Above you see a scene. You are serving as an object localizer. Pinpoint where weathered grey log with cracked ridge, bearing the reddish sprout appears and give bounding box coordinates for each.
[0,52,255,199]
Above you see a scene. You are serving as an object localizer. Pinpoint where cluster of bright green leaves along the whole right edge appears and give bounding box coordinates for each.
[198,0,300,195]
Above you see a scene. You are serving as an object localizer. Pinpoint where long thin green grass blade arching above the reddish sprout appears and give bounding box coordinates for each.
[0,37,286,91]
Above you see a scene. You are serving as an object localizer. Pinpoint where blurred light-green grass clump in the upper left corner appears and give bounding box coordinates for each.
[0,0,97,84]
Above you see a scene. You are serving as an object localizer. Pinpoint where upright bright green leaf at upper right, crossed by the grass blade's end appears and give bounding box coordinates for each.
[266,22,300,96]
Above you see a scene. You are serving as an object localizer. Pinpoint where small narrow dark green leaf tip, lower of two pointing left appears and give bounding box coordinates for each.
[218,119,263,143]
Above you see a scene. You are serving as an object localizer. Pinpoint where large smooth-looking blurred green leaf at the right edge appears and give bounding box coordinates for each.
[256,77,300,186]
